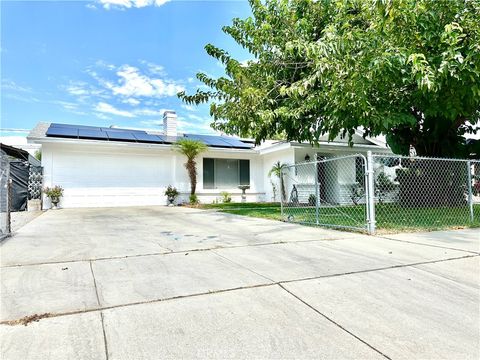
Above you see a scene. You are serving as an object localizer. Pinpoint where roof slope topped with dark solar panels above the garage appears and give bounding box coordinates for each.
[28,123,254,149]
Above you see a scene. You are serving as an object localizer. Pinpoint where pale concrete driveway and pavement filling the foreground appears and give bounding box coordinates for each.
[0,207,480,360]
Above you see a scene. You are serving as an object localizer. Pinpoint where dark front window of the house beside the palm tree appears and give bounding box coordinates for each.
[203,158,250,189]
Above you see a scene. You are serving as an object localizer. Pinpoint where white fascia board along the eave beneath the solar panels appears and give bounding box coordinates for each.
[27,137,258,154]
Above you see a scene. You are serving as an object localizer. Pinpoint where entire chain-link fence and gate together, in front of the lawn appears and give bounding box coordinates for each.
[280,153,480,233]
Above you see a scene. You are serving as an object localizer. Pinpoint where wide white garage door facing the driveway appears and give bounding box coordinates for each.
[46,151,173,207]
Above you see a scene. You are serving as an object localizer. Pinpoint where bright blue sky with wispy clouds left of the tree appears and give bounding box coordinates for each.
[0,0,250,136]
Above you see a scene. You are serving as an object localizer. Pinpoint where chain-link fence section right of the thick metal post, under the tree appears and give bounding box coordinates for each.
[373,155,480,230]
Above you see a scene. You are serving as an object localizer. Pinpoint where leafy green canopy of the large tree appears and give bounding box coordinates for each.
[179,0,480,156]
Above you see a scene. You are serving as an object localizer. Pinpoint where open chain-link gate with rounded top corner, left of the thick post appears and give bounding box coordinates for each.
[279,154,374,232]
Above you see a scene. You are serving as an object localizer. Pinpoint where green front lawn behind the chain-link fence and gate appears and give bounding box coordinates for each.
[201,203,480,232]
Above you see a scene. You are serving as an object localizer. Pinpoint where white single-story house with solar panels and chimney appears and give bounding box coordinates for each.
[27,111,391,208]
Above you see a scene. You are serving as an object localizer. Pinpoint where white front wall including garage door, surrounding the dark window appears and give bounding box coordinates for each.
[42,143,265,208]
